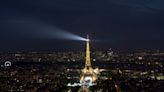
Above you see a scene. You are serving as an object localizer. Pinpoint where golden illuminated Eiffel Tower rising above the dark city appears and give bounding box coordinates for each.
[80,35,95,84]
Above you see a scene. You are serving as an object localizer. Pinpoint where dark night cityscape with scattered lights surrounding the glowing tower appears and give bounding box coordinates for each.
[0,50,164,92]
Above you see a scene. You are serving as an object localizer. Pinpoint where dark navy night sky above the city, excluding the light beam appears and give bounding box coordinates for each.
[0,0,164,51]
